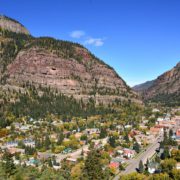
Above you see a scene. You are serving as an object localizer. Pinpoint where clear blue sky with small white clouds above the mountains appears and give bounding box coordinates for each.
[0,0,180,86]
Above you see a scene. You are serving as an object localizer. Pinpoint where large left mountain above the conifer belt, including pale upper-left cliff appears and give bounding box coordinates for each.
[0,16,139,104]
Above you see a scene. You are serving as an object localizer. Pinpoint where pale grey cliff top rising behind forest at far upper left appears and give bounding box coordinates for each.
[0,16,29,34]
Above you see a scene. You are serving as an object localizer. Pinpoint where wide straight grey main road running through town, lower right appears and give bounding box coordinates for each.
[114,136,162,180]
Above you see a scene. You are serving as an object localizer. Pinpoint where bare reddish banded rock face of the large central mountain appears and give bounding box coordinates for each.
[6,48,137,104]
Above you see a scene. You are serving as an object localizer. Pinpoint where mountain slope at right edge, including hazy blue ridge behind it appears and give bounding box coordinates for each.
[134,62,180,105]
